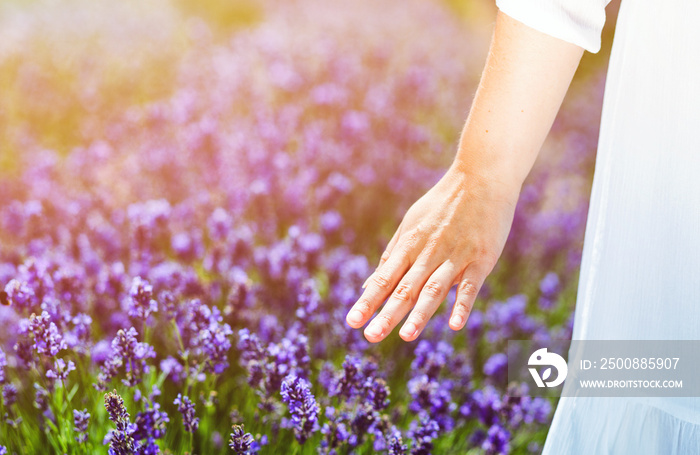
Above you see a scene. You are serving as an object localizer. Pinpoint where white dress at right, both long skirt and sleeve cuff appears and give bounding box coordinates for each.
[496,0,700,455]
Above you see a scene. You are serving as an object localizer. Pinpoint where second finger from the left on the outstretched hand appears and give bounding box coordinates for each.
[365,258,439,343]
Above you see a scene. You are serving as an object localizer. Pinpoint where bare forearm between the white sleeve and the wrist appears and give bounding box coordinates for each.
[453,11,583,190]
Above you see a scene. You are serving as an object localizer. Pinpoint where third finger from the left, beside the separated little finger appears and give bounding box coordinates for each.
[399,260,459,341]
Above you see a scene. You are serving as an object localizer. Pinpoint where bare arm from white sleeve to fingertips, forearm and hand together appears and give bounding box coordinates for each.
[346,11,583,342]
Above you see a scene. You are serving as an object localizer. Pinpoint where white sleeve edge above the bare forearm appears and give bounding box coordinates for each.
[496,0,610,54]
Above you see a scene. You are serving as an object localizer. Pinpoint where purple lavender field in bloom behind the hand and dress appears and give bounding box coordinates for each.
[0,0,604,455]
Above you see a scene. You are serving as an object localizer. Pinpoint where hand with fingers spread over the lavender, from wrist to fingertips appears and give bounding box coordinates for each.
[346,167,520,343]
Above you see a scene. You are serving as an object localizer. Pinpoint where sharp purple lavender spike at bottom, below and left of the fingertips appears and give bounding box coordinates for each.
[281,375,320,444]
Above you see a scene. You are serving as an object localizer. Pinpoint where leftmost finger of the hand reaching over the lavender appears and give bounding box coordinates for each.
[345,240,413,329]
